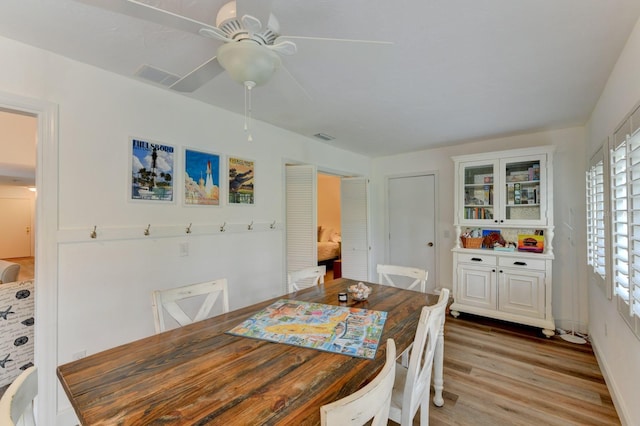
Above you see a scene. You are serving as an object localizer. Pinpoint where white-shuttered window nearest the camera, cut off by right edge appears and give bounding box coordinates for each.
[608,109,640,337]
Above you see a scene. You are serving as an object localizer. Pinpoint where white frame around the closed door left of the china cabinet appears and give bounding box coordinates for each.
[384,170,438,291]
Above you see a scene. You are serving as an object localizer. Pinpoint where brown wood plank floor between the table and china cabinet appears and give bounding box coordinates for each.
[398,314,620,426]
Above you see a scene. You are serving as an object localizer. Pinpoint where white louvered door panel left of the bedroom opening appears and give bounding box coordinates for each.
[286,165,318,286]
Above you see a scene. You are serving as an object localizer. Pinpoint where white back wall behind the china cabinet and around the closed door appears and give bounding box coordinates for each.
[371,127,587,328]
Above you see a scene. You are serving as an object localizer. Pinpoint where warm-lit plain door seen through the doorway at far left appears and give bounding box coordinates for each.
[0,198,31,259]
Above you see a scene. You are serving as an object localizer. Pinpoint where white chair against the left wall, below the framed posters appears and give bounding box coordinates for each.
[153,278,229,333]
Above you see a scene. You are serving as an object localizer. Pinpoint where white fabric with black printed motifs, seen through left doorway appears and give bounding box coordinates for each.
[0,280,35,386]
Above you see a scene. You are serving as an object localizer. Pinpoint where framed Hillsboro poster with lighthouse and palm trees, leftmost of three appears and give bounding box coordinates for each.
[129,138,175,202]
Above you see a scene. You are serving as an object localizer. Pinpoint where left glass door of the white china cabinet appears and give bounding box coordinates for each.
[461,163,497,222]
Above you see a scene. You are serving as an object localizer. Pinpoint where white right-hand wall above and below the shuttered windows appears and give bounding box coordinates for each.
[586,14,640,425]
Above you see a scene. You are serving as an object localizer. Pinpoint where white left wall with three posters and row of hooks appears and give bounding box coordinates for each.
[0,38,370,422]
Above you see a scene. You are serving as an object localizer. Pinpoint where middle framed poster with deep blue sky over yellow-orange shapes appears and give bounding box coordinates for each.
[184,148,220,206]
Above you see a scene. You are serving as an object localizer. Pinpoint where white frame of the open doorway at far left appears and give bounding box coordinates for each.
[0,91,58,424]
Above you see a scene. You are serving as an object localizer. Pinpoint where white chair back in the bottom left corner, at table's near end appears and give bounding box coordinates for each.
[0,366,38,426]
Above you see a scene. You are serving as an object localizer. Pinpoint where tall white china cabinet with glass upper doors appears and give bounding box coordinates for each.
[451,147,555,336]
